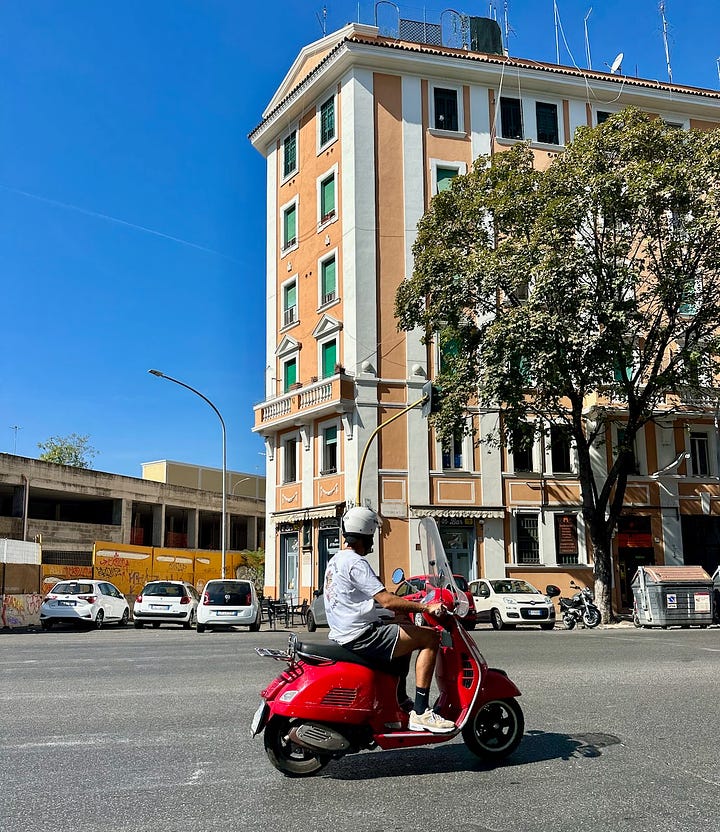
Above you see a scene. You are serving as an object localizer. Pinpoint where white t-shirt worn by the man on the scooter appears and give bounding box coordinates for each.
[323,549,392,644]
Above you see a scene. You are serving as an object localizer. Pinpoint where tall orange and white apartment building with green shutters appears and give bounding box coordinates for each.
[250,9,720,606]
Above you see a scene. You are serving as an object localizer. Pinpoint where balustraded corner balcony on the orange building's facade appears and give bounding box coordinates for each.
[253,373,355,433]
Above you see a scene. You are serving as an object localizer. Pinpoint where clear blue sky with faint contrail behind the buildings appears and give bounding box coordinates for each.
[0,0,720,476]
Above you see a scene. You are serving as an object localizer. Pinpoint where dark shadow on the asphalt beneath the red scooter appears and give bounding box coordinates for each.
[330,731,622,780]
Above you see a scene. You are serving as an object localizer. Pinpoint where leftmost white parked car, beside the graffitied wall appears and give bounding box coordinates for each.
[40,578,130,630]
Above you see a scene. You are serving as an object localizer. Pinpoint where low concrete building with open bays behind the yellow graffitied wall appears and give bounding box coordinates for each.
[0,454,265,566]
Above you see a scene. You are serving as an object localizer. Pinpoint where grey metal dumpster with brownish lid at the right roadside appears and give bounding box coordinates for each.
[631,566,713,627]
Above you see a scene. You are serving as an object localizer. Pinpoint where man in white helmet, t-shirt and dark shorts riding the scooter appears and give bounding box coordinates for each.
[324,506,456,734]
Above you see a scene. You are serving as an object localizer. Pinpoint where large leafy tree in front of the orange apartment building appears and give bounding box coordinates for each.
[396,109,720,621]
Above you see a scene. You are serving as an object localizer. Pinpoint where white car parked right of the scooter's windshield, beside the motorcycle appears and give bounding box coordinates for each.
[470,578,555,630]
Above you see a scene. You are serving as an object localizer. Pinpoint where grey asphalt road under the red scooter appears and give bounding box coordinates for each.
[0,627,720,832]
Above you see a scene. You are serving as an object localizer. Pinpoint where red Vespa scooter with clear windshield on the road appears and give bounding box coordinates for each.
[251,518,525,777]
